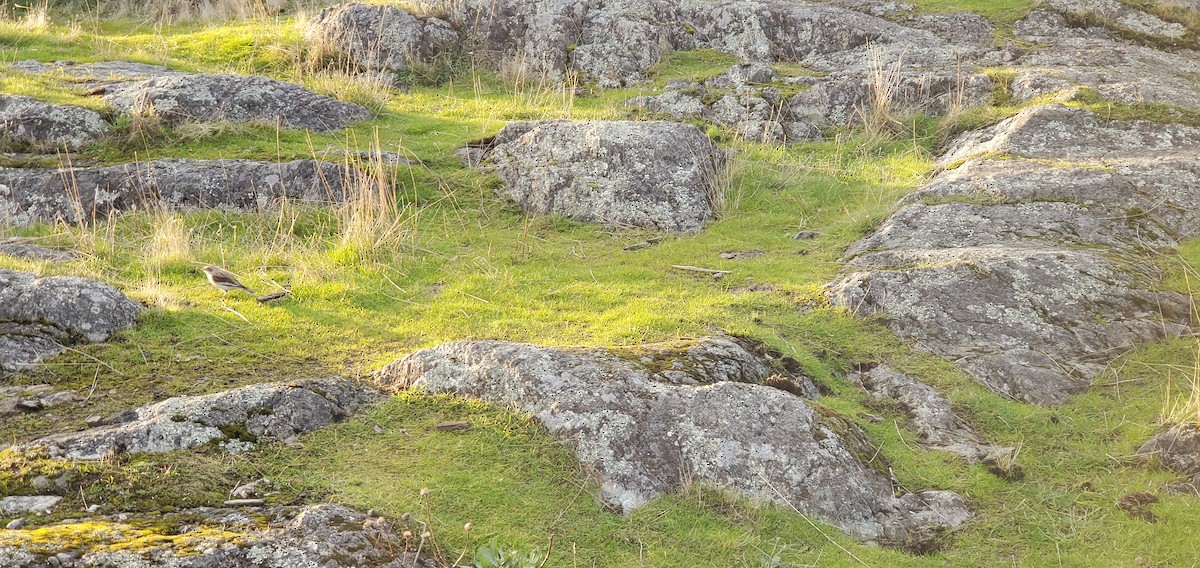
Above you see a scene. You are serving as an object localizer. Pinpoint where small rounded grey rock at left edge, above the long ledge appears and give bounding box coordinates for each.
[0,95,109,150]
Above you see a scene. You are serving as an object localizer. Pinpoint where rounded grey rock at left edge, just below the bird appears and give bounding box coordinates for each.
[0,269,142,376]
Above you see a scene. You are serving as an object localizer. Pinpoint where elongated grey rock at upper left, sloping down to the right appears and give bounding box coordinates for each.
[12,61,373,132]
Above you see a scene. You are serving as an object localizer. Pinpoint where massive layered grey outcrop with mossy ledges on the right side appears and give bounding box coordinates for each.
[829,106,1200,405]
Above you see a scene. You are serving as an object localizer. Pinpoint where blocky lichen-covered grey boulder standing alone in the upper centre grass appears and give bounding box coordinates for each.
[487,120,725,232]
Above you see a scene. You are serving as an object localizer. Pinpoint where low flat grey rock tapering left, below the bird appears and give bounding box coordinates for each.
[16,378,379,460]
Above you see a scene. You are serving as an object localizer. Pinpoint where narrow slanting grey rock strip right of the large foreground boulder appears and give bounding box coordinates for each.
[847,365,1015,464]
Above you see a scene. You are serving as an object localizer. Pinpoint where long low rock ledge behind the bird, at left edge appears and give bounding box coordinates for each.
[0,160,361,226]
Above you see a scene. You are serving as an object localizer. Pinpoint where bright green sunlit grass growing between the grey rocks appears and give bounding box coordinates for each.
[0,2,1200,567]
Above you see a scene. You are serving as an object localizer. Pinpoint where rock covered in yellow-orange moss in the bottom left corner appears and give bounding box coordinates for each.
[0,504,439,568]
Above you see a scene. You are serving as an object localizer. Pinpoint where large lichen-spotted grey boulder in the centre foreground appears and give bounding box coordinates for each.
[377,339,971,544]
